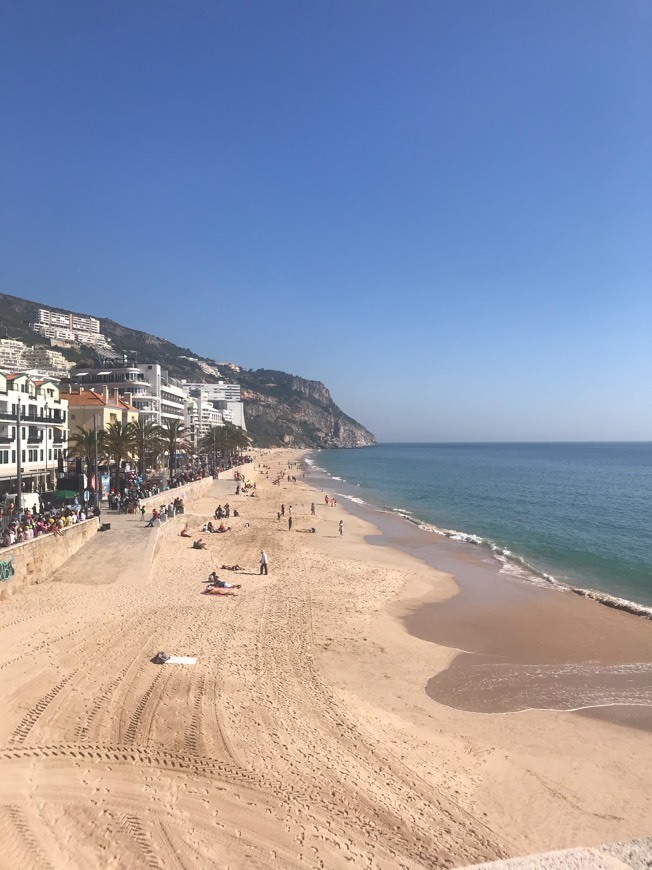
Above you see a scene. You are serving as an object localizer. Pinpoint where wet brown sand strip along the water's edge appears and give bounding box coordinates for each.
[306,456,652,731]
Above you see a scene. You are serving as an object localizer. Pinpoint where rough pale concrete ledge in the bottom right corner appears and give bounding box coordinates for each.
[459,837,652,870]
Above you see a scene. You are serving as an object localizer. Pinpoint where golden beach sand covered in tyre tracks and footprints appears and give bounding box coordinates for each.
[0,450,652,868]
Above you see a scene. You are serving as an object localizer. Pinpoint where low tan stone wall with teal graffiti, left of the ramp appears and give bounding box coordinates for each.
[0,517,100,600]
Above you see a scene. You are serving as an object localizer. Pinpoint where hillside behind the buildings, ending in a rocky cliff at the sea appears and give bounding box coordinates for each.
[0,293,376,447]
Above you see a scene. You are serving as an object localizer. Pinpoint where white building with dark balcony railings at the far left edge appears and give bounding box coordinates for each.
[0,372,68,505]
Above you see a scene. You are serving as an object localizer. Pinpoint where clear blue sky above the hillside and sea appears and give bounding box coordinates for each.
[0,0,652,440]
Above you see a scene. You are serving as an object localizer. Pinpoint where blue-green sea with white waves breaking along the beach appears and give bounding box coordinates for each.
[312,442,652,606]
